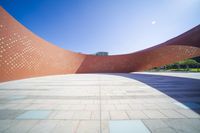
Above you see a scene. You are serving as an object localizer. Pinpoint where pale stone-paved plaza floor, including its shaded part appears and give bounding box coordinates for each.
[0,73,200,133]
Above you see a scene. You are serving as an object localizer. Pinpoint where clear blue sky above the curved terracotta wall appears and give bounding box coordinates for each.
[0,0,200,54]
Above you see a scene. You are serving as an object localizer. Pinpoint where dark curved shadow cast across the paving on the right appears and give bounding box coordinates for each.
[110,73,200,114]
